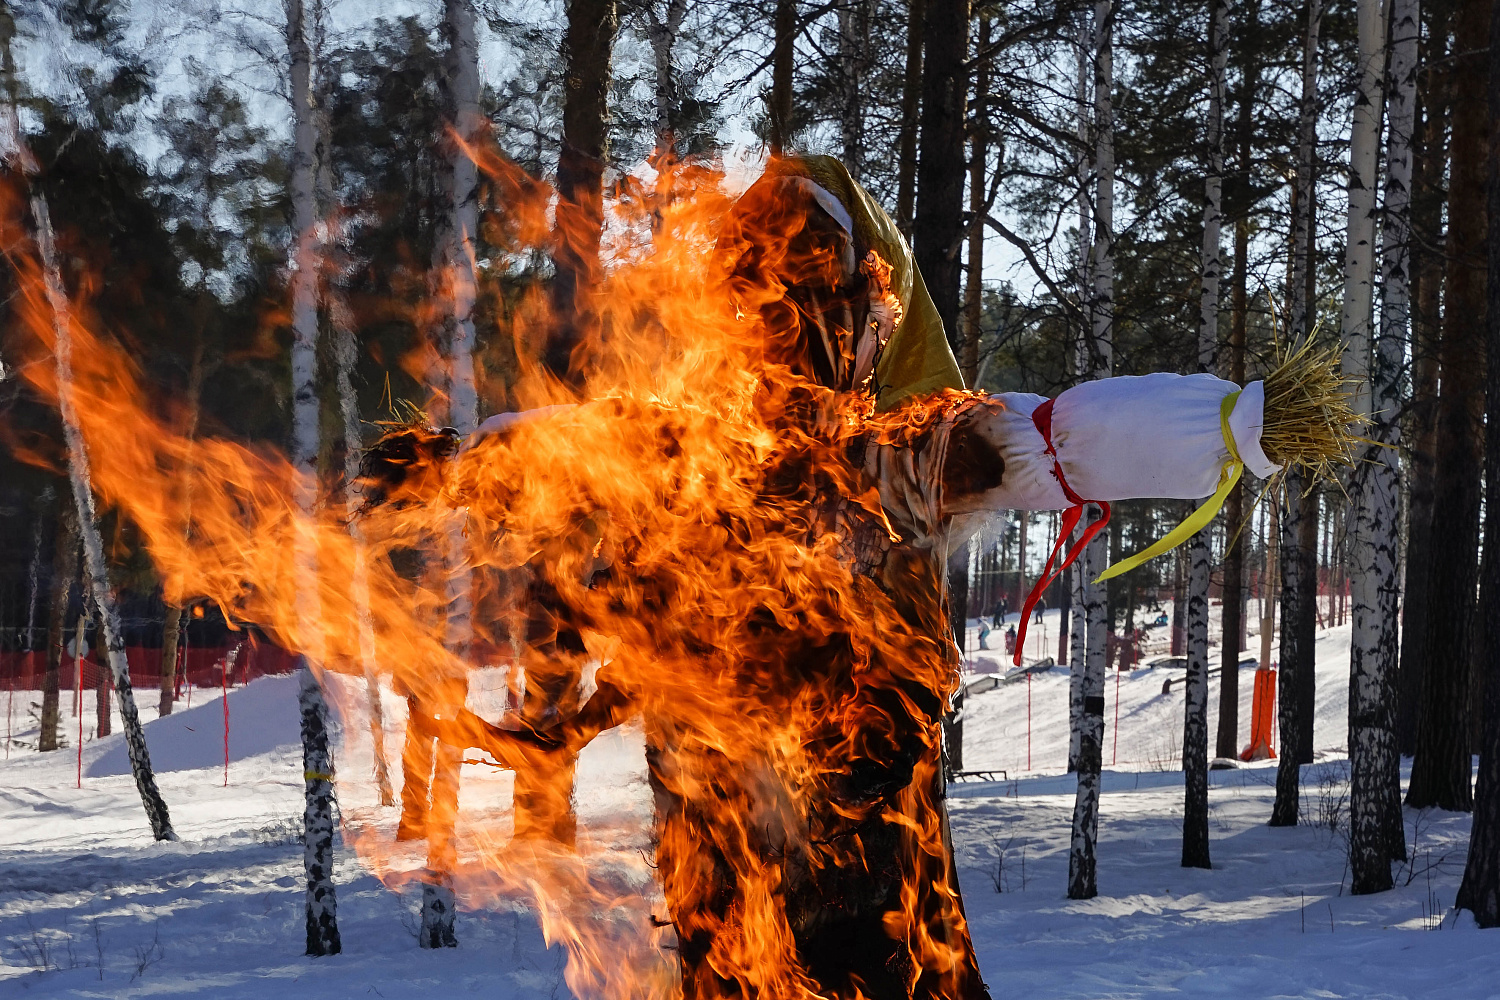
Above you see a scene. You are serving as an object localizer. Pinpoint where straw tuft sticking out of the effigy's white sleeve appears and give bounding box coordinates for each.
[1260,337,1359,483]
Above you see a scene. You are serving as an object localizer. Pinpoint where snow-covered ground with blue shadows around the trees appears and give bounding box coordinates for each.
[0,613,1500,1000]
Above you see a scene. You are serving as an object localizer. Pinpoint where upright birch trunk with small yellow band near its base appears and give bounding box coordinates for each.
[285,0,342,955]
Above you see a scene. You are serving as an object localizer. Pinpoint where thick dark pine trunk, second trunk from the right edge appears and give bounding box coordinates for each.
[1407,0,1490,813]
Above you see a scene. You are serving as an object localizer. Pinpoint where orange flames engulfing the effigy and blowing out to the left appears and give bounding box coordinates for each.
[5,157,984,1000]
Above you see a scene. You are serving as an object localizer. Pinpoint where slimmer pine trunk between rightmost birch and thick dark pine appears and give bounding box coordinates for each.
[1397,4,1449,756]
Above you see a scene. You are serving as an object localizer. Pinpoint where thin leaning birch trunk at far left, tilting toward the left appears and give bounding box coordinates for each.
[32,203,177,840]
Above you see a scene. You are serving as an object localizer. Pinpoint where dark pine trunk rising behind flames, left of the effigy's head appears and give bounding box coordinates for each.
[543,0,618,388]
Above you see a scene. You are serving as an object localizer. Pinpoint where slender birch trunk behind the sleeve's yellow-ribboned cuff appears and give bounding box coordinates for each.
[1182,0,1230,868]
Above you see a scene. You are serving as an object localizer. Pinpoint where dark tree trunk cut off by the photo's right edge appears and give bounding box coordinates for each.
[1454,4,1500,928]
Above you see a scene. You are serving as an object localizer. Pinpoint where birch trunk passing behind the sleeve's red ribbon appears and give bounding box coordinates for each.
[1068,0,1115,900]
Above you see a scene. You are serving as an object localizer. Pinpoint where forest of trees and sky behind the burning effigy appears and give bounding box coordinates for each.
[0,0,1500,935]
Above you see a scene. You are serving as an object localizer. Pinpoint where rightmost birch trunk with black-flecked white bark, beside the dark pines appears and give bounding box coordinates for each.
[1346,0,1419,894]
